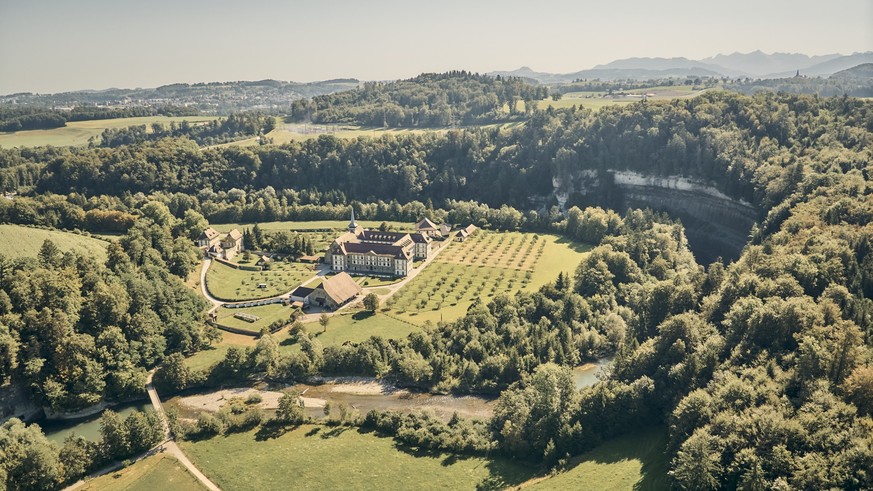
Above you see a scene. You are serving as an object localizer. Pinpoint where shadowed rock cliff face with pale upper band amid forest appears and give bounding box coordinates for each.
[556,170,758,264]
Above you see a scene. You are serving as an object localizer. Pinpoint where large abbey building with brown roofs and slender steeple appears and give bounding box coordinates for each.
[324,208,432,277]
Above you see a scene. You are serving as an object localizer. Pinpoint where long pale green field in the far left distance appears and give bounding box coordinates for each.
[0,116,218,148]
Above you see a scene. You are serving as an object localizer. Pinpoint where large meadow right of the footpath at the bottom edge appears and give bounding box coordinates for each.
[180,425,533,491]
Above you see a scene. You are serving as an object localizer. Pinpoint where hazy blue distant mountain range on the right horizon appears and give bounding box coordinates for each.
[489,51,873,84]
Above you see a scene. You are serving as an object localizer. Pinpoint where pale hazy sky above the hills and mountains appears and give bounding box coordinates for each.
[0,0,873,94]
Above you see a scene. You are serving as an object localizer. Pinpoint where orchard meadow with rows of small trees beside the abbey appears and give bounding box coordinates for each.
[384,230,589,325]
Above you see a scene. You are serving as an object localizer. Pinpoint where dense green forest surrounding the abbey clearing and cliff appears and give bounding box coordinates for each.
[0,84,873,489]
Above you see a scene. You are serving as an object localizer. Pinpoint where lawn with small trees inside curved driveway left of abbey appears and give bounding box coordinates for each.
[206,261,316,302]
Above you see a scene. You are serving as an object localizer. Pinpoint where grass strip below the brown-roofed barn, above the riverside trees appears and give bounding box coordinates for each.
[283,310,420,349]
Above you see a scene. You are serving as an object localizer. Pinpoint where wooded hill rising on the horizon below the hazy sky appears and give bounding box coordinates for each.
[289,71,549,128]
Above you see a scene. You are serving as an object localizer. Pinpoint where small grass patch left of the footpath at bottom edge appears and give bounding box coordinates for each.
[79,454,206,491]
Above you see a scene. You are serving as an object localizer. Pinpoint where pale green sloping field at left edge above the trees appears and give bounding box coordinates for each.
[0,224,109,263]
